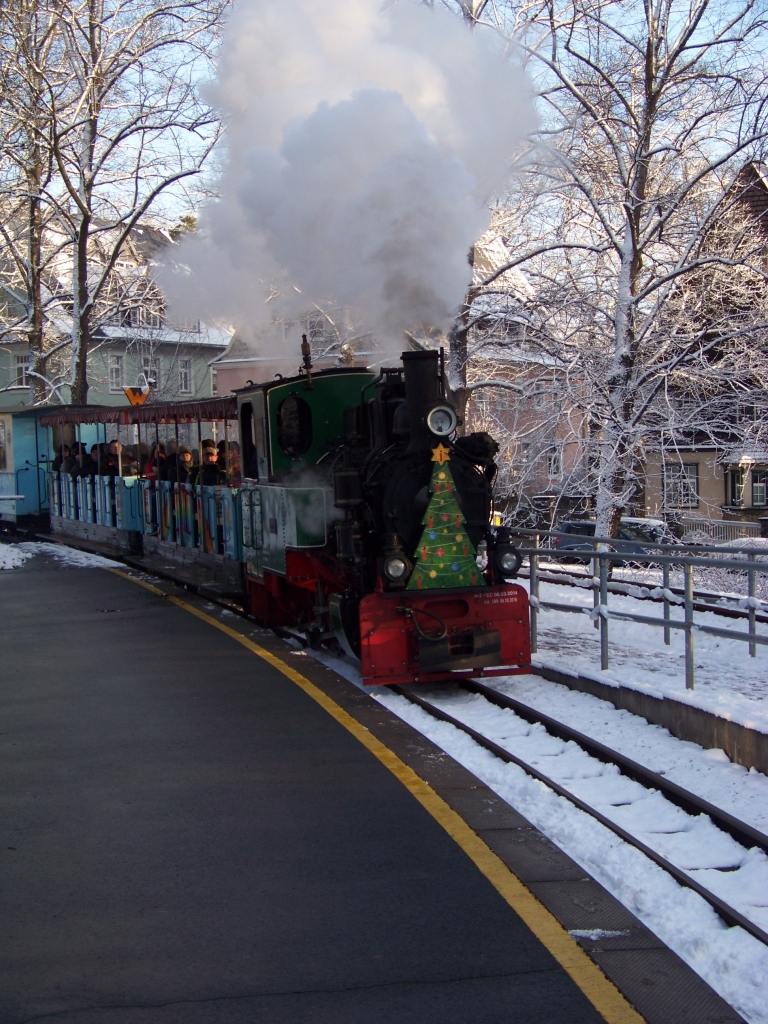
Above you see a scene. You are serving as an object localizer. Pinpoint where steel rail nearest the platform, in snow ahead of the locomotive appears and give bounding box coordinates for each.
[389,686,768,945]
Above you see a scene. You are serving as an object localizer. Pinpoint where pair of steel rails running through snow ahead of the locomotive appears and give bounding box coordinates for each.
[390,680,768,945]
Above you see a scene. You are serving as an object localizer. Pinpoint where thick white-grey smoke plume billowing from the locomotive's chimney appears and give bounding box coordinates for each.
[164,0,531,347]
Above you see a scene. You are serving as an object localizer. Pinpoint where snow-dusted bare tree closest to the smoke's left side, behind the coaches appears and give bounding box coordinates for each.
[52,0,224,403]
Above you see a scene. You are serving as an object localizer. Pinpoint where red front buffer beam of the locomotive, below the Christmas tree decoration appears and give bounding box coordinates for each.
[359,584,530,686]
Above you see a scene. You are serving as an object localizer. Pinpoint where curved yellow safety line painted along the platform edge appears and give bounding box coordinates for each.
[109,569,645,1024]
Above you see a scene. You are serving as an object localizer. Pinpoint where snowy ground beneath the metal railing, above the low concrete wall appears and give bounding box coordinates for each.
[521,581,768,732]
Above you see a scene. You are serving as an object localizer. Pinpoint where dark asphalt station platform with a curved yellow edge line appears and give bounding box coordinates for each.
[0,555,740,1024]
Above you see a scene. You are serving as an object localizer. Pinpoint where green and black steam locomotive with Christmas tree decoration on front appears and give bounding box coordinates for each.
[238,342,530,685]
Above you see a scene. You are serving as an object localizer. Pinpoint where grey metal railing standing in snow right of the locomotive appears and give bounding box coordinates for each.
[515,529,768,690]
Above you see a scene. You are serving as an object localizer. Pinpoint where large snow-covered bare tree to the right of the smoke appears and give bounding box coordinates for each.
[452,0,768,535]
